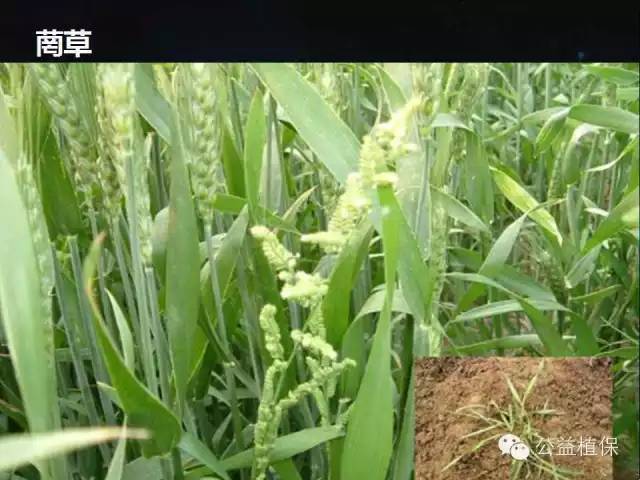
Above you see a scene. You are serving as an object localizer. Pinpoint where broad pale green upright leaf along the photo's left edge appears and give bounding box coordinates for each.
[0,150,64,479]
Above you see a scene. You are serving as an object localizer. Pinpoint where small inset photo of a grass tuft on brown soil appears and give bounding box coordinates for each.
[415,357,619,480]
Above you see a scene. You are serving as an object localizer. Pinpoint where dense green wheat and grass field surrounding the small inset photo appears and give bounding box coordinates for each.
[0,63,640,480]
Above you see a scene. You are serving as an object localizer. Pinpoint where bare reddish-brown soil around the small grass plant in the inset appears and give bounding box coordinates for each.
[415,357,613,480]
